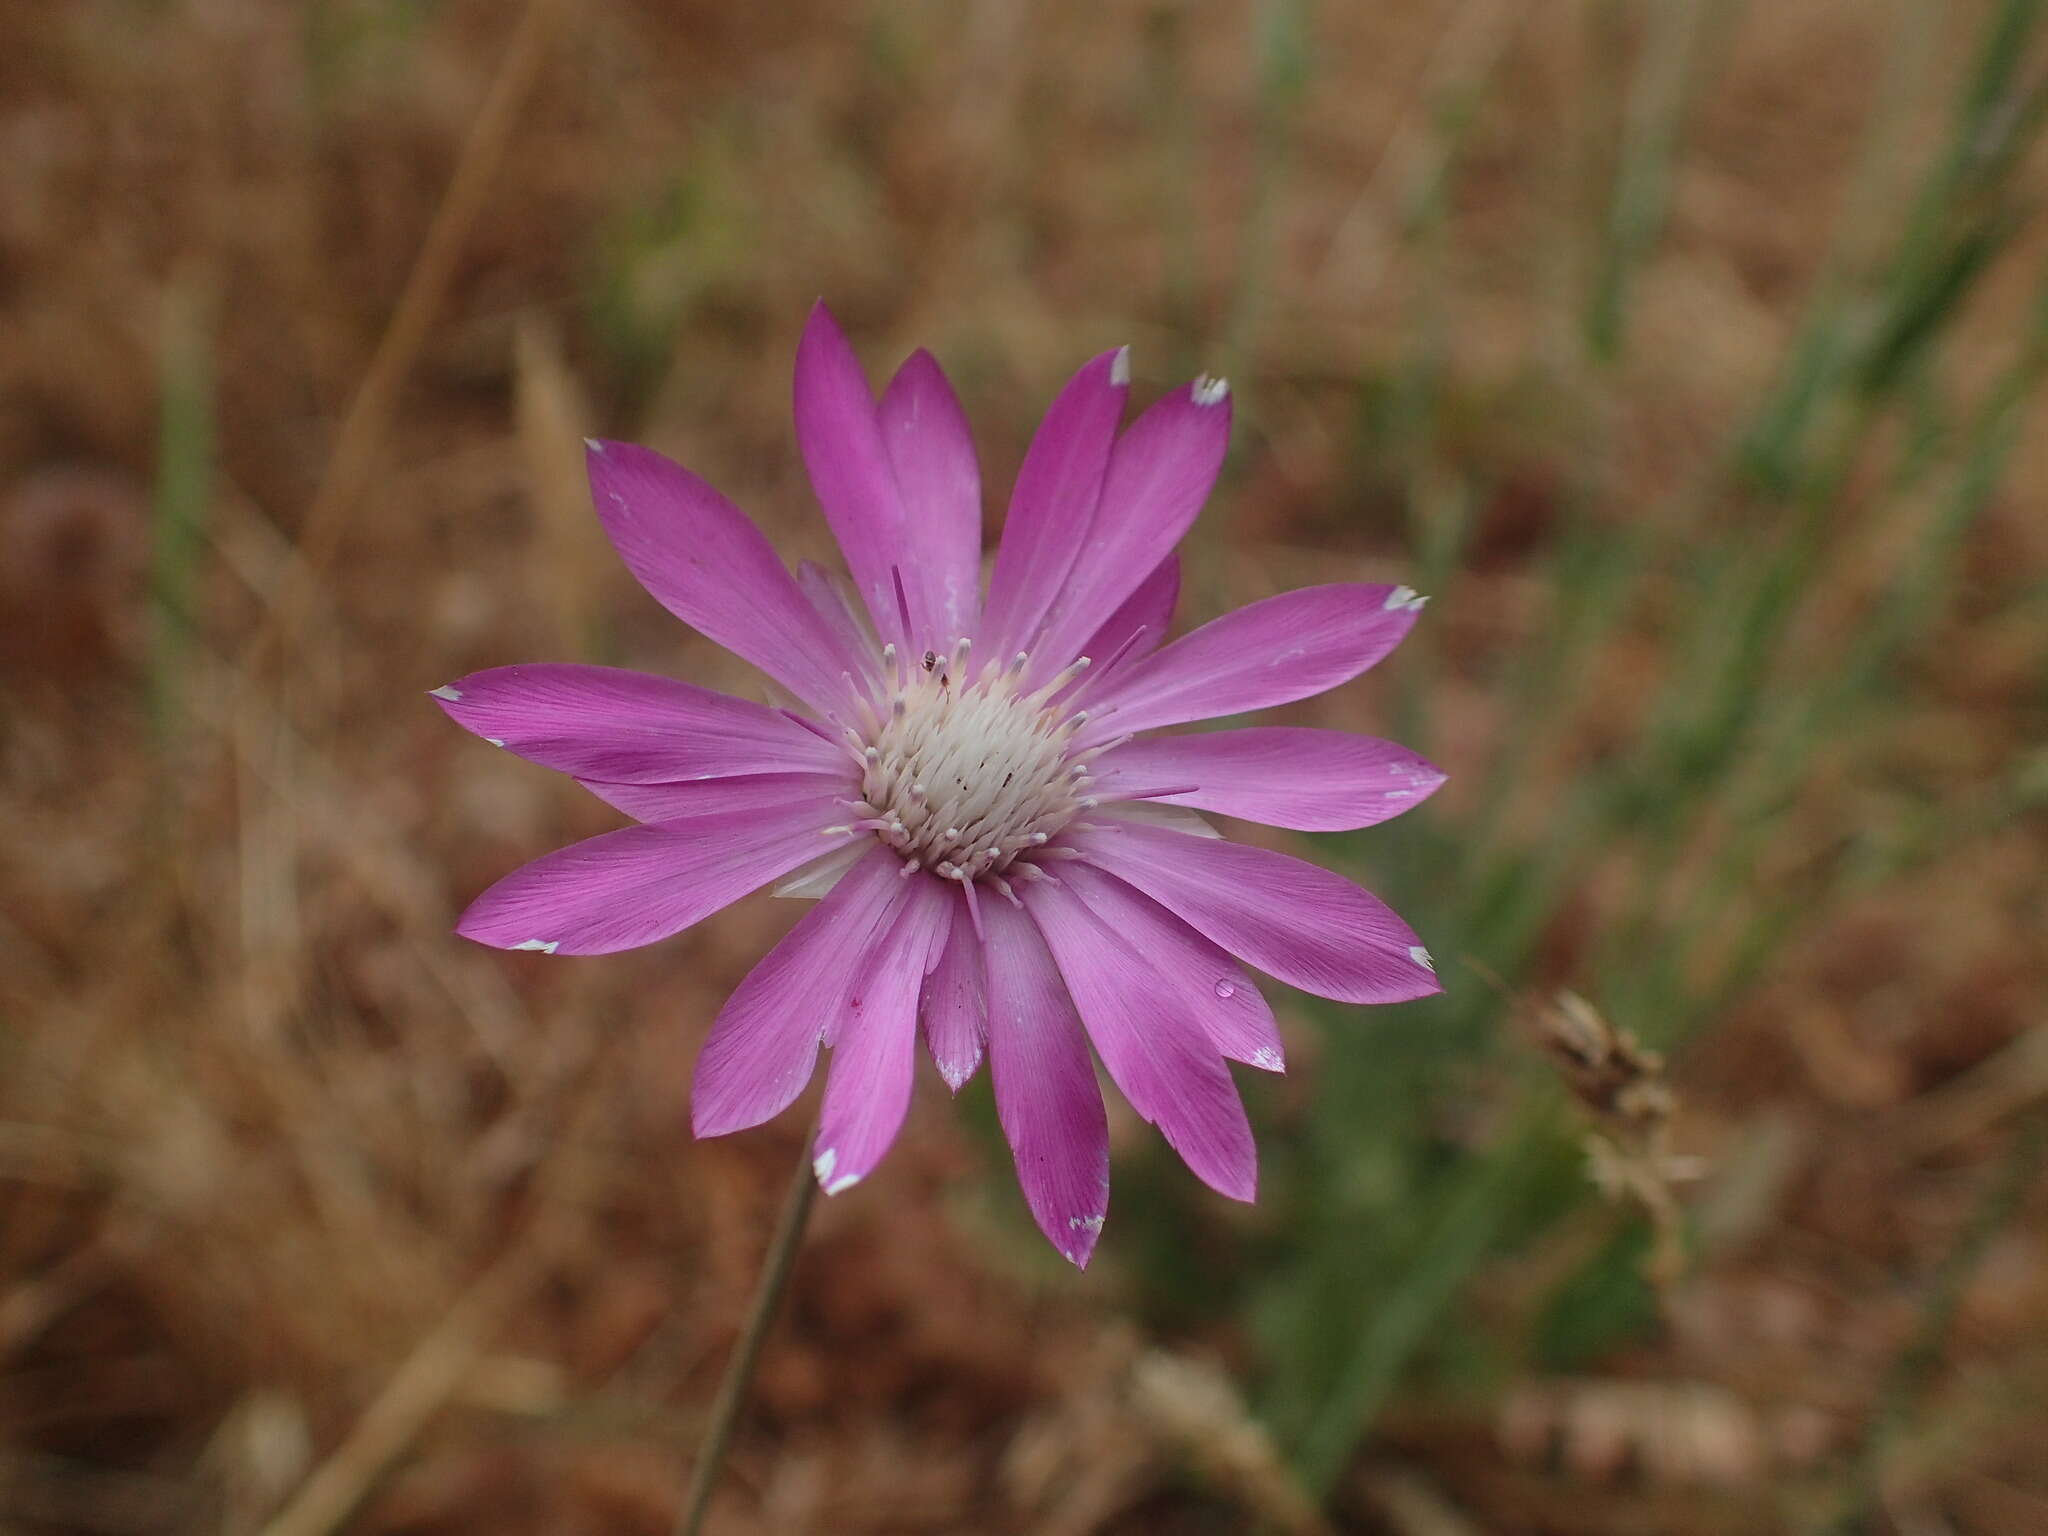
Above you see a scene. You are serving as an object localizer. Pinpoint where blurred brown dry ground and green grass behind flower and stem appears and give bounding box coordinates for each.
[0,0,2048,1536]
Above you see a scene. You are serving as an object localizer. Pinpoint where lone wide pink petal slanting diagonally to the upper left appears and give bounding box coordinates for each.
[588,442,858,711]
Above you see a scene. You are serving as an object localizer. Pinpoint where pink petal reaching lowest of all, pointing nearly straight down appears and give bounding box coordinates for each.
[983,901,1110,1268]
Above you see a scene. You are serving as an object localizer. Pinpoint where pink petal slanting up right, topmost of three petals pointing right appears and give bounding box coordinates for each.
[1083,584,1421,741]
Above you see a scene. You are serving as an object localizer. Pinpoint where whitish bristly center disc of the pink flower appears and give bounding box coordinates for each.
[860,641,1094,883]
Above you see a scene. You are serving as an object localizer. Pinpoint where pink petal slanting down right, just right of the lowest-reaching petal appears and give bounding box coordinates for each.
[1019,881,1257,1200]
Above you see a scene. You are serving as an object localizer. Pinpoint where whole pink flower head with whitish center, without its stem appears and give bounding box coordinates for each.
[434,305,1442,1264]
